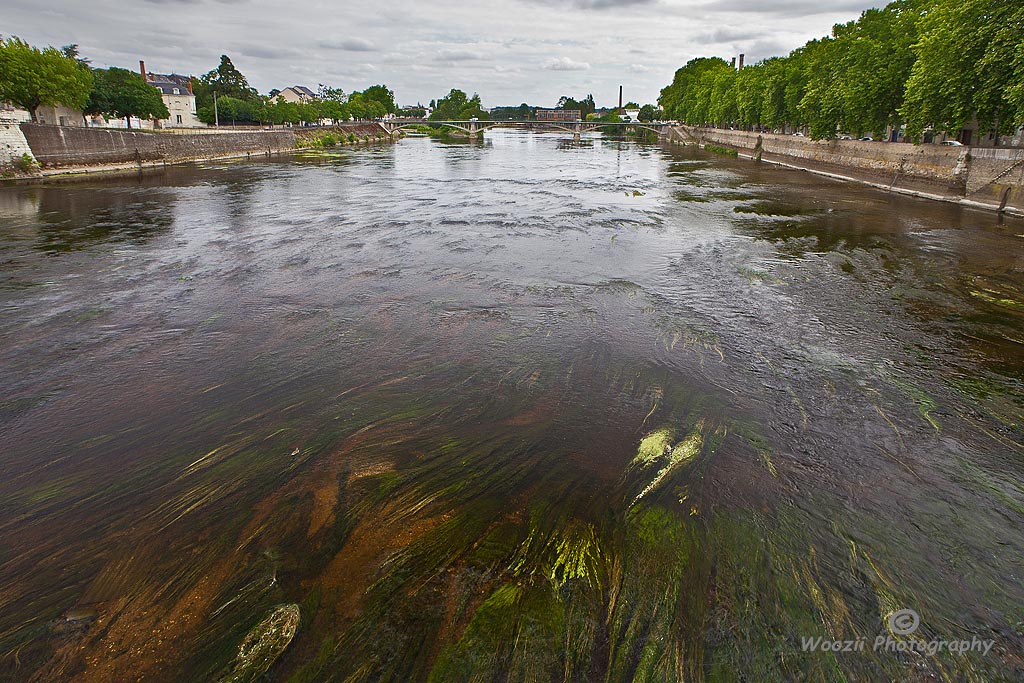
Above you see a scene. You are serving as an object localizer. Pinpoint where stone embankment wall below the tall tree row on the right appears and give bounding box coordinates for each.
[669,126,1024,215]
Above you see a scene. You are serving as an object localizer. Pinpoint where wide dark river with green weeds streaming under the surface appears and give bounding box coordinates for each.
[0,130,1024,683]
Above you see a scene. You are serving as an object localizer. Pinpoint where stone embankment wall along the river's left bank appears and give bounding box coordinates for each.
[2,123,392,179]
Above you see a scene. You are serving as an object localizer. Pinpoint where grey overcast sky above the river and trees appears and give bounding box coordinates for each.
[0,0,885,106]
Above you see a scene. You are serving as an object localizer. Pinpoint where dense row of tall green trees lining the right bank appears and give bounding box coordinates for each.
[658,0,1024,139]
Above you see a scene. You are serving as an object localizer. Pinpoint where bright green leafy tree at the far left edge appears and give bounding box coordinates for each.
[0,37,92,121]
